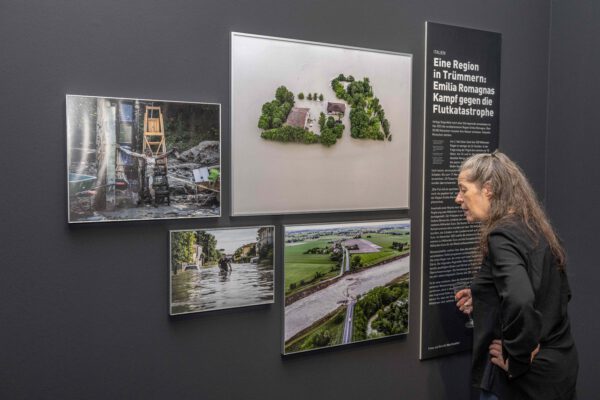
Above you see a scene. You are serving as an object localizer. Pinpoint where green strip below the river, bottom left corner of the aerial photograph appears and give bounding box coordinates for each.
[285,306,346,353]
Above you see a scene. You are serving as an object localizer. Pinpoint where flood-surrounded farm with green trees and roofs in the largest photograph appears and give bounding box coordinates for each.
[258,74,392,147]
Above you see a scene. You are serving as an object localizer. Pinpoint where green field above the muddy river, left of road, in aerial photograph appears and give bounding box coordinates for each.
[284,238,339,296]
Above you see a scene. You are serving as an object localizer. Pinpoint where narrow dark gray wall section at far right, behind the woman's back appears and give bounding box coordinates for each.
[546,0,600,399]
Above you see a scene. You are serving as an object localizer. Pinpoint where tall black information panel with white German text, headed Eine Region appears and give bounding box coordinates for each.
[420,22,501,359]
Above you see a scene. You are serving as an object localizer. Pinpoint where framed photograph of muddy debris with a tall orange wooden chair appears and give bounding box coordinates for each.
[66,95,221,223]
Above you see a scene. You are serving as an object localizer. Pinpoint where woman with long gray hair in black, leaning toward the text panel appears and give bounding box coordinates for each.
[455,151,578,400]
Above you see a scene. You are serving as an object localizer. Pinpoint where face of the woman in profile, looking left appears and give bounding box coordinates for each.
[454,171,492,222]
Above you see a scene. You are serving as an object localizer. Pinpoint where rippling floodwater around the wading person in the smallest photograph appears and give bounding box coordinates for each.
[171,263,273,314]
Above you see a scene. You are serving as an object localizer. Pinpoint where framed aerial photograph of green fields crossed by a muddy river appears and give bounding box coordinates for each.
[283,220,411,354]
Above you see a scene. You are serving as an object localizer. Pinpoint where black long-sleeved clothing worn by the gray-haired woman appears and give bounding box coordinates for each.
[471,218,578,400]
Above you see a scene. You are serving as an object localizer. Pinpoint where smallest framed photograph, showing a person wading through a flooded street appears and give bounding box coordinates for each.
[169,226,275,315]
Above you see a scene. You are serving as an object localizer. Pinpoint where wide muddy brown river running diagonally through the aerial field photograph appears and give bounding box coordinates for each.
[284,257,410,341]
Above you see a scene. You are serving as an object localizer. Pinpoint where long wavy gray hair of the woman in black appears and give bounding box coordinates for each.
[460,150,566,269]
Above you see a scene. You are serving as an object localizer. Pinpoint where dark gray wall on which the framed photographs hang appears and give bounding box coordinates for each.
[0,0,552,400]
